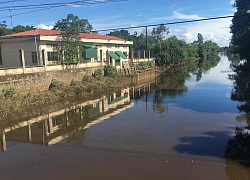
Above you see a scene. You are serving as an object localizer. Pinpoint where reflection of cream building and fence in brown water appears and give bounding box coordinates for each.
[0,88,133,151]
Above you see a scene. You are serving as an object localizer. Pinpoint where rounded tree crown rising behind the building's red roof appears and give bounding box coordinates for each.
[53,14,93,33]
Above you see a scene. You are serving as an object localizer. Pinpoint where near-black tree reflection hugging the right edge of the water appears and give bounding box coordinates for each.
[225,58,250,166]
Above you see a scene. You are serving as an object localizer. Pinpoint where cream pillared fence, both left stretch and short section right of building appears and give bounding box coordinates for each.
[0,50,155,76]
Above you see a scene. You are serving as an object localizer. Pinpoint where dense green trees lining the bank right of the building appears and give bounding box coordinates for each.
[109,25,220,66]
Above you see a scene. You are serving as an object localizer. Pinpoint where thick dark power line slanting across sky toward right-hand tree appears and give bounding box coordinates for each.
[96,15,234,32]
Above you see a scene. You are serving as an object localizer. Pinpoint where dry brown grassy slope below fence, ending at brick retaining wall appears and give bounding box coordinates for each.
[0,74,132,121]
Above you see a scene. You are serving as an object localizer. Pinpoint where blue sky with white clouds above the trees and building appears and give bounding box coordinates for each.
[0,0,236,46]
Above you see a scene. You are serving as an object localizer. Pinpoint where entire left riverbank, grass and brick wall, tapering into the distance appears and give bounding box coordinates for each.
[0,59,197,124]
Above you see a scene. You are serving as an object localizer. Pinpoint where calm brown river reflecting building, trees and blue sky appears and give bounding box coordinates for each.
[0,55,250,180]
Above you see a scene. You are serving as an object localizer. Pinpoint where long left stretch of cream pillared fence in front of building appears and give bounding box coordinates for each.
[0,50,103,76]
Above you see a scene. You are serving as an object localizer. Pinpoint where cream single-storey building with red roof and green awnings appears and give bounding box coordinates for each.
[0,29,133,68]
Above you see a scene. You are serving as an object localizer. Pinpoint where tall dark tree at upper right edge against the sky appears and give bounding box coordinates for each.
[230,0,250,59]
